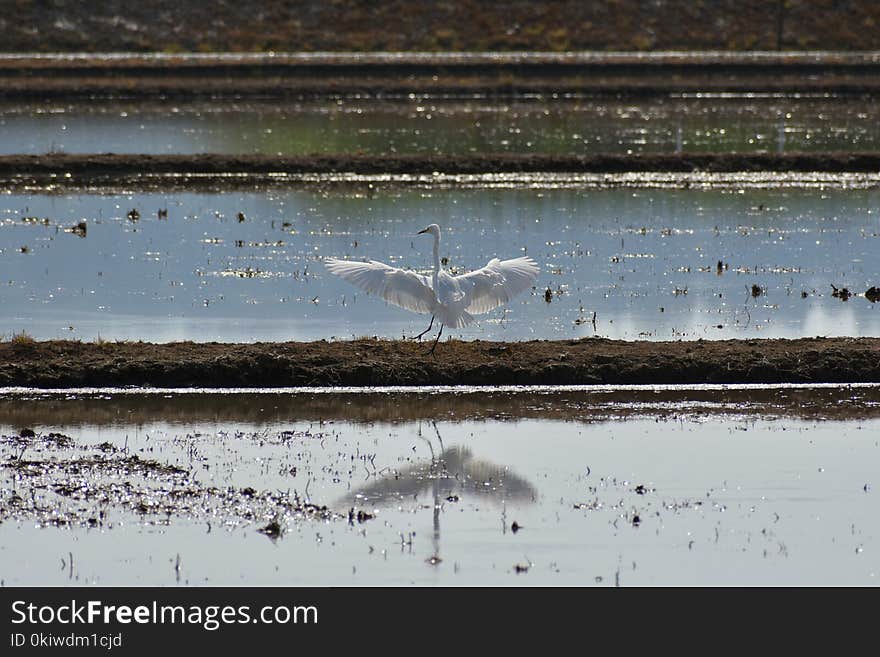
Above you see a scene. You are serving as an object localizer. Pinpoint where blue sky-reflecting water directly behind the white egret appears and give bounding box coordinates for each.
[0,183,880,341]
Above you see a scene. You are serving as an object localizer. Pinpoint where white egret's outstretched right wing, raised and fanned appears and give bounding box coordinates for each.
[455,257,541,314]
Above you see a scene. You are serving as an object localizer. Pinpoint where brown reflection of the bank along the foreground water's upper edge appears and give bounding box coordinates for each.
[0,384,880,426]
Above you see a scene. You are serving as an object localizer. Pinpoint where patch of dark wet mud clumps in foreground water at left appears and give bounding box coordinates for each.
[0,429,345,539]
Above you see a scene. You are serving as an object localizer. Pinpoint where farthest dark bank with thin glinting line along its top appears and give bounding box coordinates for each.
[0,52,880,100]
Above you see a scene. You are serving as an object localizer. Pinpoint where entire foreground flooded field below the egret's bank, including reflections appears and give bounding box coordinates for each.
[0,386,880,586]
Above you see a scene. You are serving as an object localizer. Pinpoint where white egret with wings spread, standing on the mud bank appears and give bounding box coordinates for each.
[324,224,541,354]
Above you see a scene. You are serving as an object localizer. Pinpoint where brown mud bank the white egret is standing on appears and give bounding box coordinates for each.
[0,338,880,388]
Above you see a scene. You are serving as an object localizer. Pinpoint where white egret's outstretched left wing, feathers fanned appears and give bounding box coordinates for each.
[324,258,436,313]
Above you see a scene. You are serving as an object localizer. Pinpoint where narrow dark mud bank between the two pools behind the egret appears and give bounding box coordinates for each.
[6,152,880,185]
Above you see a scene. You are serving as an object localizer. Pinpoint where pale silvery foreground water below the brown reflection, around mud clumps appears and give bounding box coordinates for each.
[0,400,880,586]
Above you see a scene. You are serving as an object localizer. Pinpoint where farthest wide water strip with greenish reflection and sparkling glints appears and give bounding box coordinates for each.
[0,94,880,155]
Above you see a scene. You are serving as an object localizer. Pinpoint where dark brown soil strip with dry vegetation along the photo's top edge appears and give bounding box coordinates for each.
[0,0,880,52]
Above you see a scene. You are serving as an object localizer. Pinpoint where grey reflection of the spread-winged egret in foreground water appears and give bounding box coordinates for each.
[343,420,537,565]
